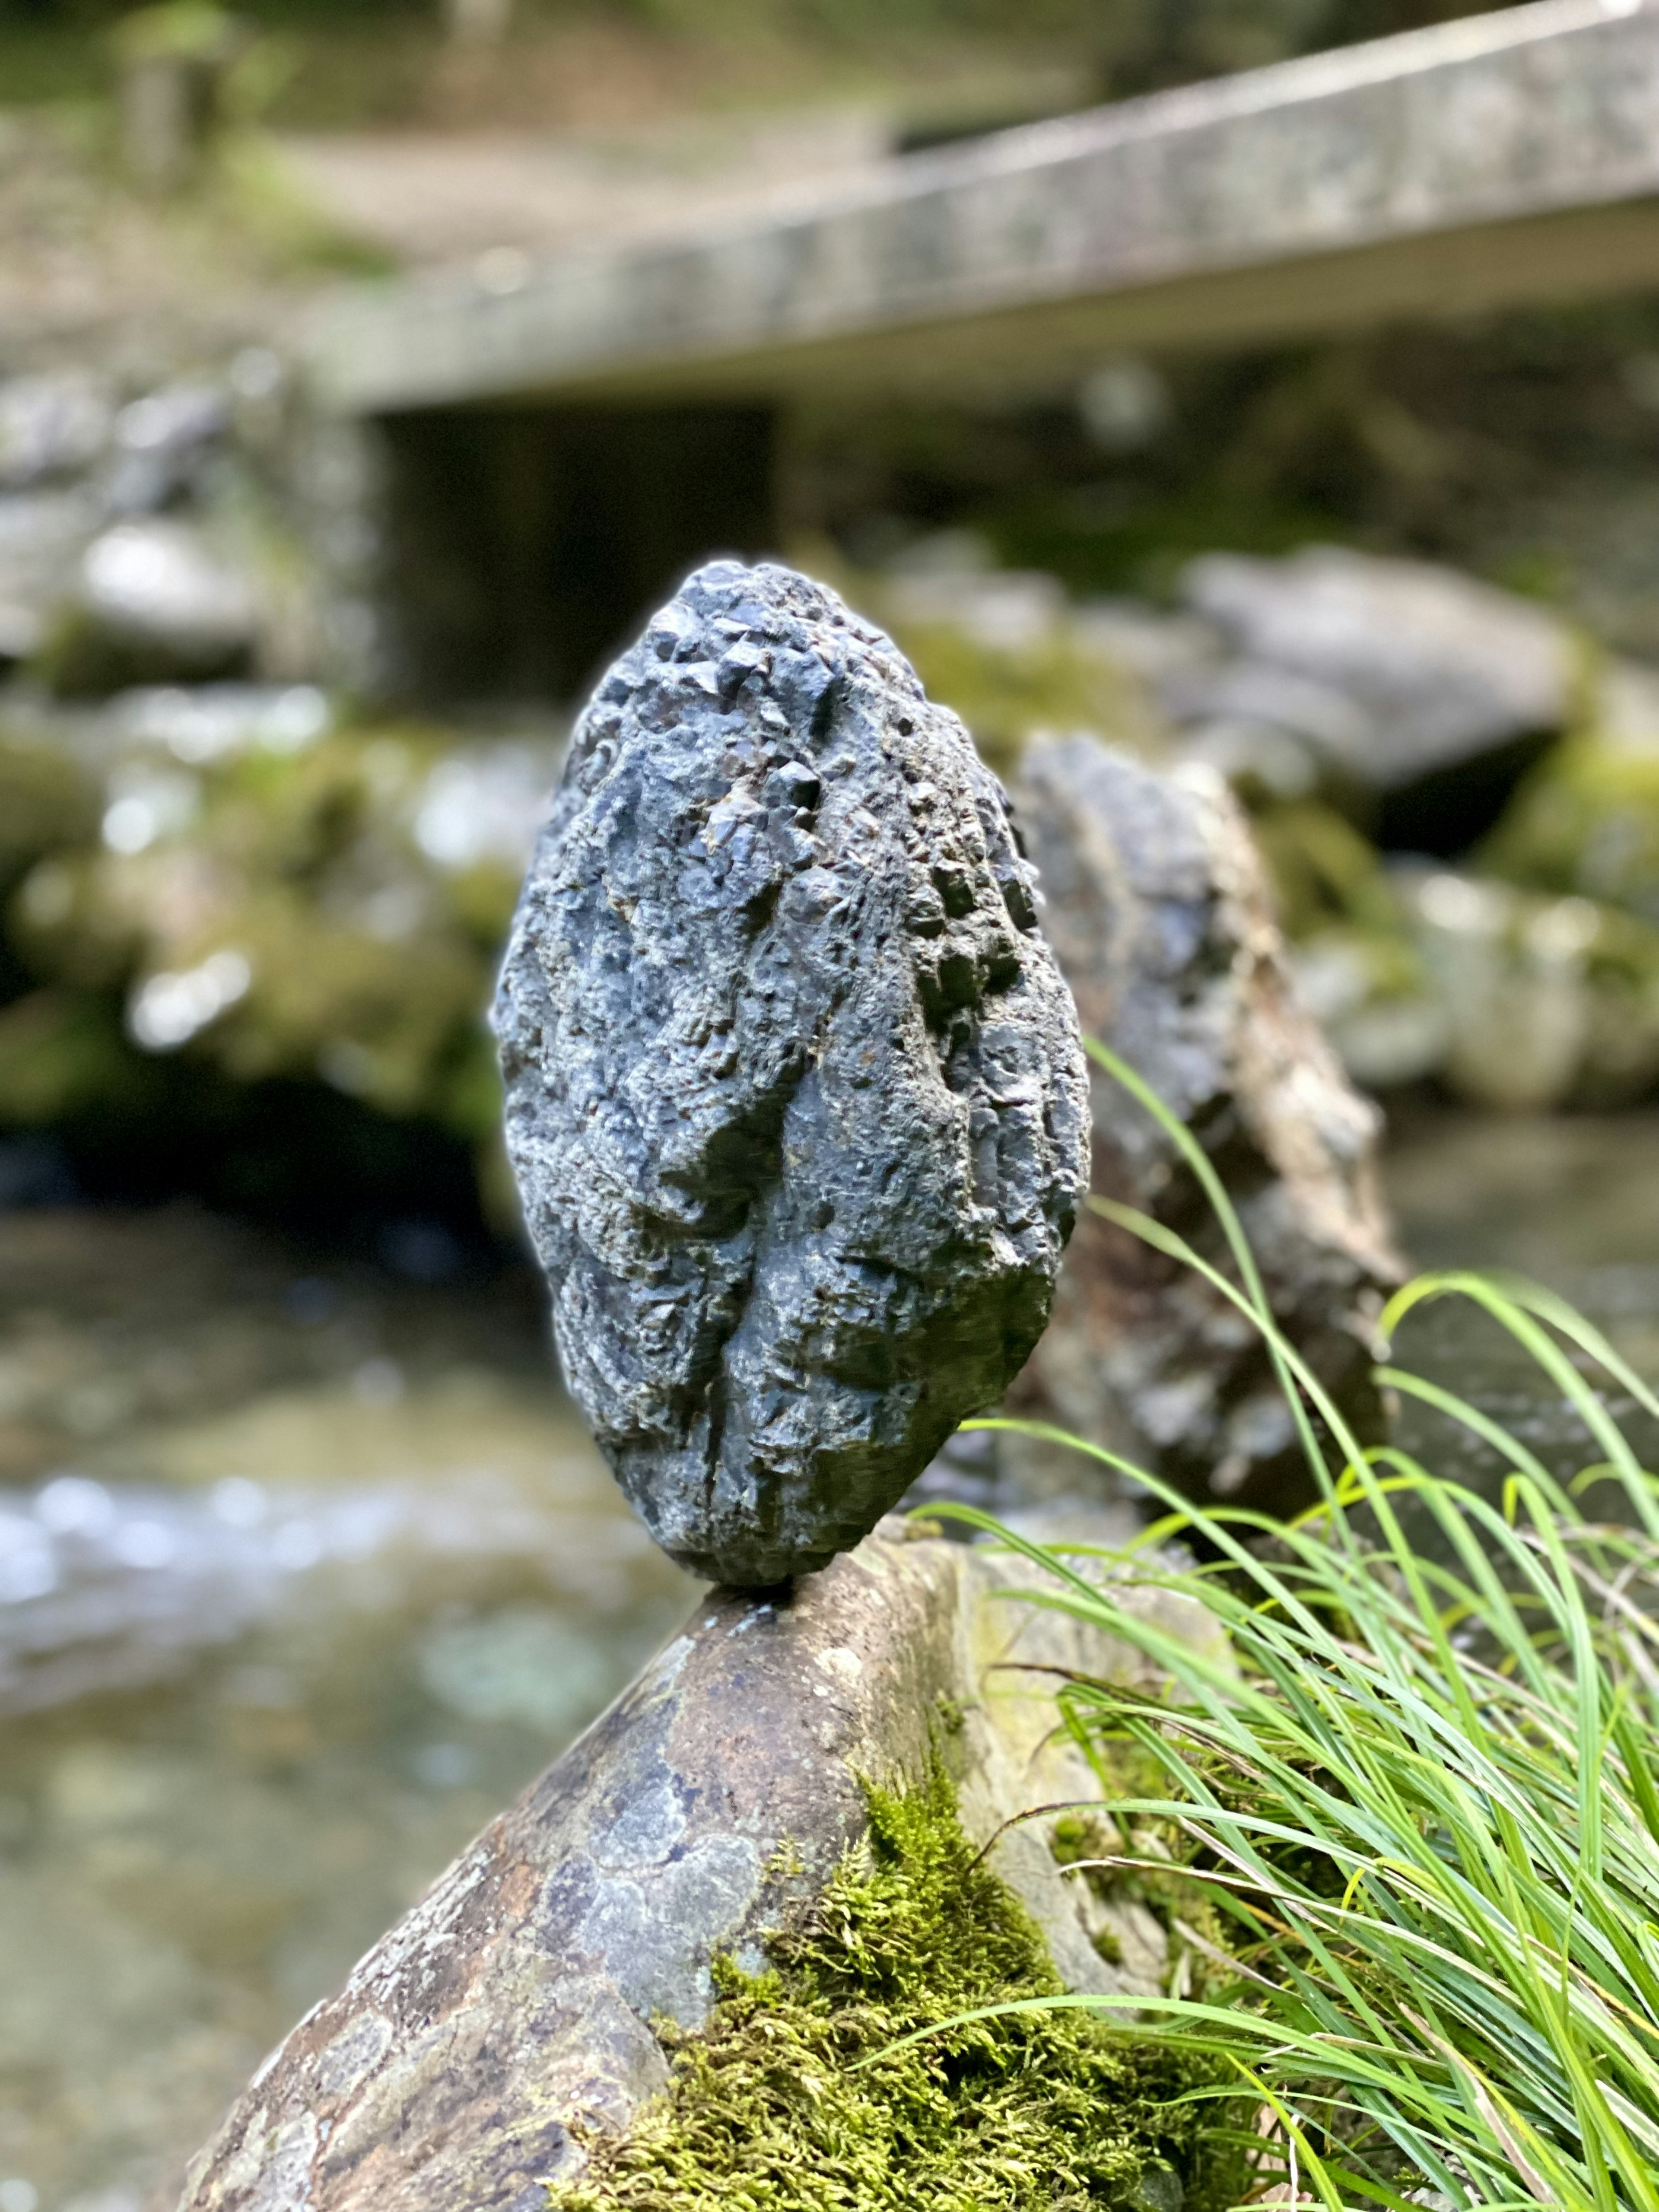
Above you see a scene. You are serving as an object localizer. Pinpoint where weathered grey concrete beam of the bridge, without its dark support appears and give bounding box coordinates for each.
[310,0,1659,411]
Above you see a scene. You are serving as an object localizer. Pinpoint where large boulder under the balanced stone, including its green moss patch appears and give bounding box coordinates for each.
[184,1522,1234,2212]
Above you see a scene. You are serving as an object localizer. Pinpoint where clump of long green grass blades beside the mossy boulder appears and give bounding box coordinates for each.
[931,1051,1659,2212]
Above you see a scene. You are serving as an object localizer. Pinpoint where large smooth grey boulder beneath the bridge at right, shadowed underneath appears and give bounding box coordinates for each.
[1168,547,1573,854]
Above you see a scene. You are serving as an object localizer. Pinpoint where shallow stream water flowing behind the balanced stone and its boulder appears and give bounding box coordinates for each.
[0,1115,1659,2212]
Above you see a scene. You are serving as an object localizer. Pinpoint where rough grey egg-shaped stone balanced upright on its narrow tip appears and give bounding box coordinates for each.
[496,562,1088,1586]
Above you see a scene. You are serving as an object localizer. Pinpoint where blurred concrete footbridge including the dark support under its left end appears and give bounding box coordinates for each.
[308,0,1659,688]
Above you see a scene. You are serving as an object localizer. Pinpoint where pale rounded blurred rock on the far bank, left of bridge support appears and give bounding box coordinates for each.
[42,518,259,695]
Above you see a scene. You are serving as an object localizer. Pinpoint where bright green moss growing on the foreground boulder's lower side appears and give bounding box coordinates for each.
[549,1770,1239,2212]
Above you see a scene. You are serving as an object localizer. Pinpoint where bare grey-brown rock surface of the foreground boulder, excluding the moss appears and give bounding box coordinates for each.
[181,1524,1221,2212]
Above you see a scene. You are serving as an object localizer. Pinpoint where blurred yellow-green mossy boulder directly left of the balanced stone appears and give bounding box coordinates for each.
[11,730,515,1137]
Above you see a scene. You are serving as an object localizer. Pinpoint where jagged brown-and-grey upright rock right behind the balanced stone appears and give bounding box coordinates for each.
[1009,737,1400,1511]
